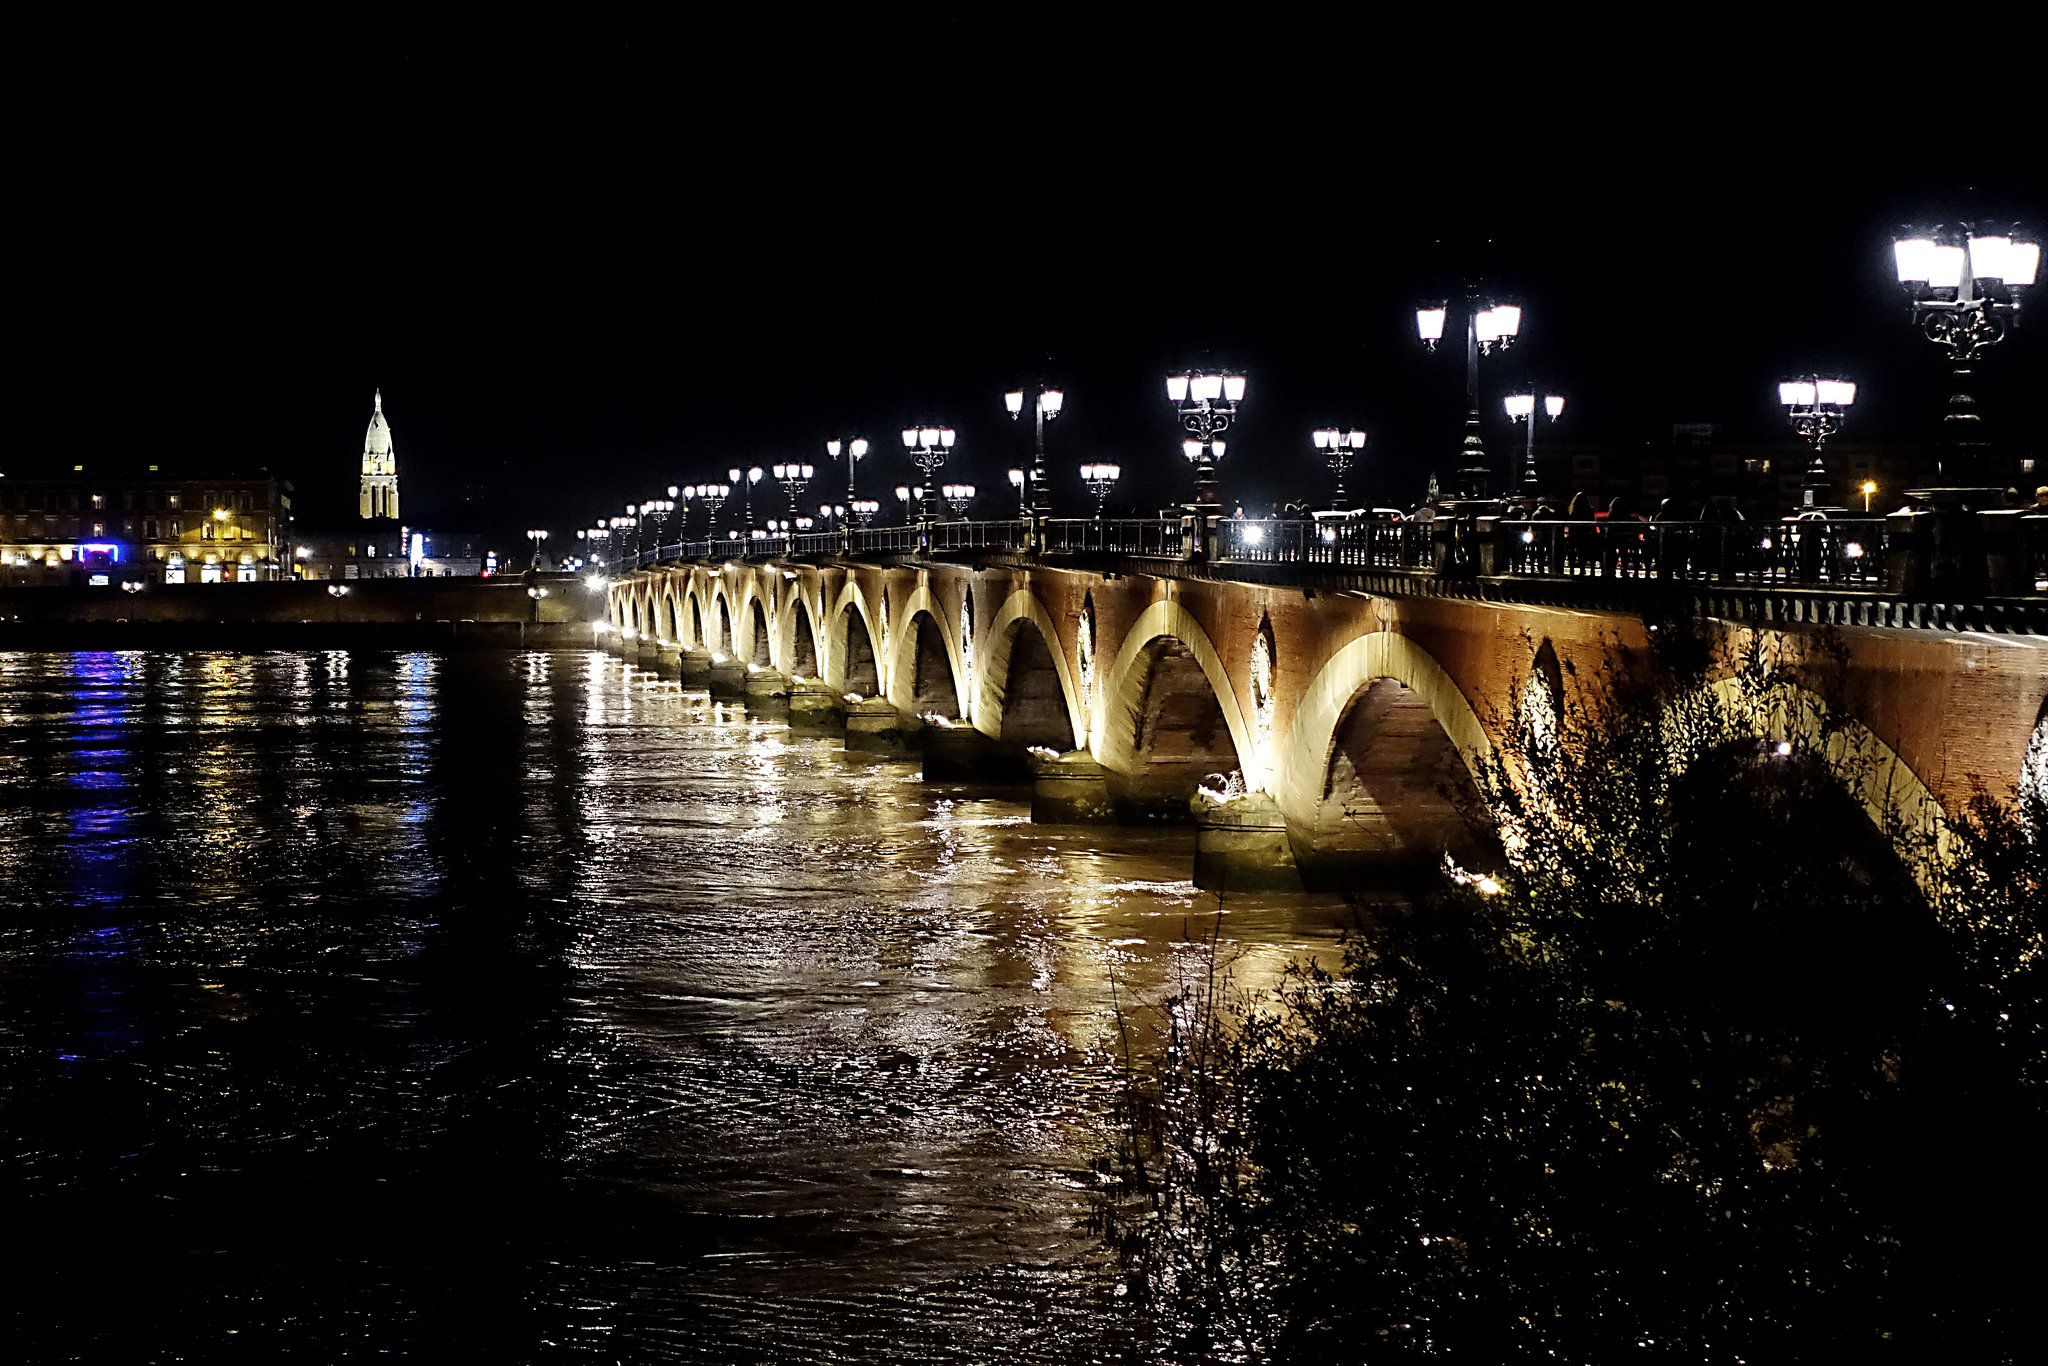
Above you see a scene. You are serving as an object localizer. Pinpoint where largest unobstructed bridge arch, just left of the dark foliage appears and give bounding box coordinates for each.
[1272,631,1493,885]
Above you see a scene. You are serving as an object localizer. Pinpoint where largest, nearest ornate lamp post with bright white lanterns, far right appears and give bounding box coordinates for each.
[1892,223,2042,481]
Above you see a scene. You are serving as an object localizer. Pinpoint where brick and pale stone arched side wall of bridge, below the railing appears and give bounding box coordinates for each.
[608,561,2048,870]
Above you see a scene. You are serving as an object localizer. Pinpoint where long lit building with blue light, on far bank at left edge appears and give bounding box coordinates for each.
[0,465,291,586]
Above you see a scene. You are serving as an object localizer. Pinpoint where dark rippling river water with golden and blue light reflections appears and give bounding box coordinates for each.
[0,651,1350,1362]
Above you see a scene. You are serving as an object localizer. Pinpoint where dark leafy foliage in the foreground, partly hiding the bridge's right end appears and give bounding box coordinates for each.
[1098,631,2048,1362]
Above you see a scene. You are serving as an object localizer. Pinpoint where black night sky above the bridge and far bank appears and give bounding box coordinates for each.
[16,12,2048,537]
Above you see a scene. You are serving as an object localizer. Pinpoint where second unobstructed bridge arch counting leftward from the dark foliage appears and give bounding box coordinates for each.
[1092,600,1264,821]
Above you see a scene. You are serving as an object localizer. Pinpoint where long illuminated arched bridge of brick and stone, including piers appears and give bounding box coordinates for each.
[602,522,2048,887]
